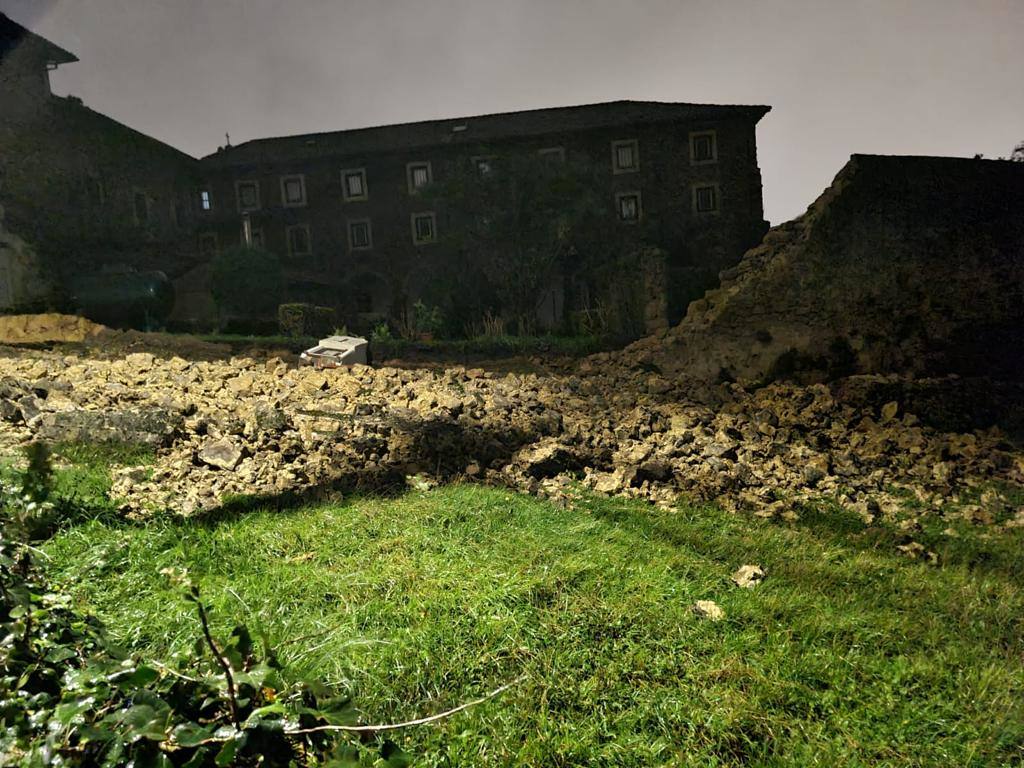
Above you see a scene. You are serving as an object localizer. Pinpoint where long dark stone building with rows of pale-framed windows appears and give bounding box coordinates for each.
[192,101,770,331]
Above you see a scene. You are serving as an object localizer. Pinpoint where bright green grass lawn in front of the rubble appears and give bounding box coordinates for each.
[39,485,1024,766]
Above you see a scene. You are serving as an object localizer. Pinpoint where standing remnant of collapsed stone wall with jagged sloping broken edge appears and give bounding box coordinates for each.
[624,155,1024,381]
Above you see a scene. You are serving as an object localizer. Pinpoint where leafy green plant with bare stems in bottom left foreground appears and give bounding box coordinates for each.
[0,456,404,768]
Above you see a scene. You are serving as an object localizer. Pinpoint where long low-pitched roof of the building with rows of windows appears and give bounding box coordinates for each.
[204,101,771,165]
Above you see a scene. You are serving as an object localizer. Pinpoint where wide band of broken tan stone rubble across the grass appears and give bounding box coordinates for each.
[0,349,1024,525]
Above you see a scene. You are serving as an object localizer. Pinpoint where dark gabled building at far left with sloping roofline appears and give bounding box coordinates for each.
[0,13,199,308]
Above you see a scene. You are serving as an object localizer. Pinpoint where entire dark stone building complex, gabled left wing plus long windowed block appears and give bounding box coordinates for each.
[0,14,770,330]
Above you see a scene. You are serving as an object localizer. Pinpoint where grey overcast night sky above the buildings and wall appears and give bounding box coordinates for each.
[0,0,1024,223]
